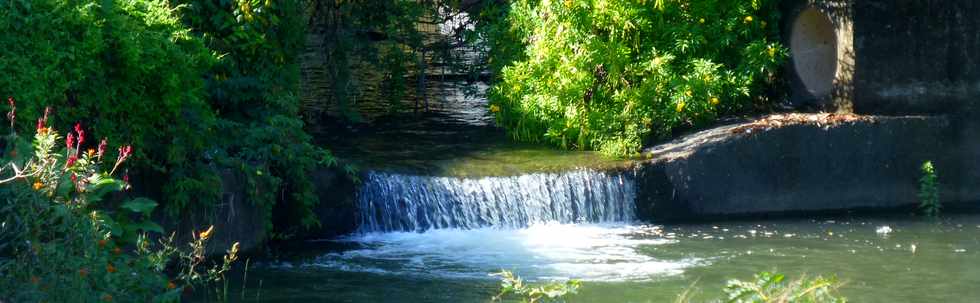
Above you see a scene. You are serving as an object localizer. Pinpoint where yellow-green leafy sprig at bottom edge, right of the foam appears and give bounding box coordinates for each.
[722,272,847,303]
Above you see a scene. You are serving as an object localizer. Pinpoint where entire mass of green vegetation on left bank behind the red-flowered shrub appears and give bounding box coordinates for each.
[0,0,333,235]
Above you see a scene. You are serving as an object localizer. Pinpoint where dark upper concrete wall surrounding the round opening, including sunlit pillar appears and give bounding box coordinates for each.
[783,0,980,115]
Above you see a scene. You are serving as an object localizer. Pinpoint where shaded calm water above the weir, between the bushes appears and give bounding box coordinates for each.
[314,82,629,177]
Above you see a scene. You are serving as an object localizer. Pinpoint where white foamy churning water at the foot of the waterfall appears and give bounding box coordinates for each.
[300,223,699,281]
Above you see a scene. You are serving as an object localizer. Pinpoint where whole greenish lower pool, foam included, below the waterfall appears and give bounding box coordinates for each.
[226,215,980,302]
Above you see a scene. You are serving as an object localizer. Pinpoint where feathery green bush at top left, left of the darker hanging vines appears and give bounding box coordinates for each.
[0,0,215,203]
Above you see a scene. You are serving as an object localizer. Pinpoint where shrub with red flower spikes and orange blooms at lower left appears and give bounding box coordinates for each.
[0,106,238,302]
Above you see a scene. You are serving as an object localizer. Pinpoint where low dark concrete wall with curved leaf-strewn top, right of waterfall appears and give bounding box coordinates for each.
[636,115,980,221]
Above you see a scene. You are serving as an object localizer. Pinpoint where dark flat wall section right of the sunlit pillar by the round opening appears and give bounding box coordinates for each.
[854,0,980,114]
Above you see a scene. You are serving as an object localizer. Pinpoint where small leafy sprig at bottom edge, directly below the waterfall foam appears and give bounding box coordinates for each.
[492,270,582,303]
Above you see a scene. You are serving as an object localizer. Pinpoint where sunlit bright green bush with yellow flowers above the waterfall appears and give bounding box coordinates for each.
[480,0,787,155]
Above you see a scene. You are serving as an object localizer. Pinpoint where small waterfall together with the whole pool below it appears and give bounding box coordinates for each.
[238,170,980,302]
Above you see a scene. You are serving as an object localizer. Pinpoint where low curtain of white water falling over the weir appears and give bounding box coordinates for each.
[357,170,635,232]
